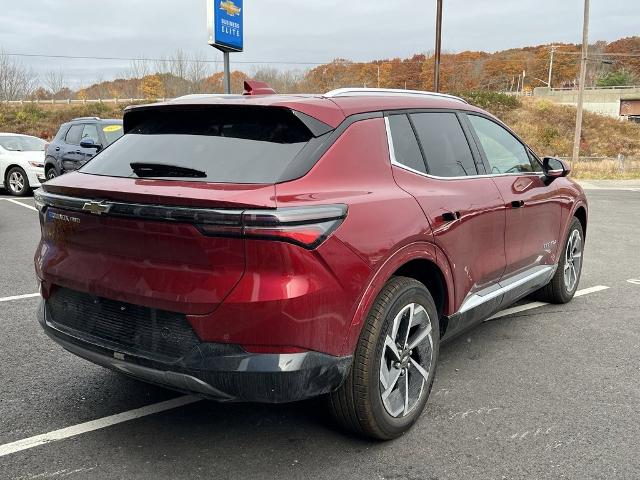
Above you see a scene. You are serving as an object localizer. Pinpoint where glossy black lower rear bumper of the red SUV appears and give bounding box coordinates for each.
[38,301,351,403]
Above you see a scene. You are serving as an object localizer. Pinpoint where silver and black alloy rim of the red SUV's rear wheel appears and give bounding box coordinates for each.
[380,303,433,418]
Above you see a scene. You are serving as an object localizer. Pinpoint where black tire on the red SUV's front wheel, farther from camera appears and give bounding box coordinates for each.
[533,217,584,303]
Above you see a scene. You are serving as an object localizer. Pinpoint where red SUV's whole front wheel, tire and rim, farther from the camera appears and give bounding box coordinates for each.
[534,217,584,303]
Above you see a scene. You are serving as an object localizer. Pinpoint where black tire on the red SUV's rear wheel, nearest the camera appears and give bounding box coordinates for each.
[329,277,440,440]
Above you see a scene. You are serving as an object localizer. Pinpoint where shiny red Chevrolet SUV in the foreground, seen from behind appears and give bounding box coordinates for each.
[35,83,587,439]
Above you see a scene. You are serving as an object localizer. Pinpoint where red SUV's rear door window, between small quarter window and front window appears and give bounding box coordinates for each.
[411,112,478,177]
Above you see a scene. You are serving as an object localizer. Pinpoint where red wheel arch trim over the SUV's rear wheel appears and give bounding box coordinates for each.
[343,242,454,355]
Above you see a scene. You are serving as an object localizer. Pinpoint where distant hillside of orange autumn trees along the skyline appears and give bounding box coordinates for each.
[34,36,640,100]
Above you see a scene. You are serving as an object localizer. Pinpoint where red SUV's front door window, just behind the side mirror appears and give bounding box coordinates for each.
[468,115,533,174]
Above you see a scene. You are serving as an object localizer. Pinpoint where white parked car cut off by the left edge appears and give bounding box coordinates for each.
[0,133,46,197]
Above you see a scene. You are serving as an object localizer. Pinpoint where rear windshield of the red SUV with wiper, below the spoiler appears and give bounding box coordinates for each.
[81,106,313,183]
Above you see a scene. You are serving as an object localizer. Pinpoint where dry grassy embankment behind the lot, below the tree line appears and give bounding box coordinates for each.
[0,92,640,178]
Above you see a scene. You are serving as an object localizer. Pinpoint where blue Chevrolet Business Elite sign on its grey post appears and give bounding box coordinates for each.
[207,0,244,93]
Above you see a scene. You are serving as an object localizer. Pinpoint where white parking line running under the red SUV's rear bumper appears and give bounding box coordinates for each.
[0,395,202,457]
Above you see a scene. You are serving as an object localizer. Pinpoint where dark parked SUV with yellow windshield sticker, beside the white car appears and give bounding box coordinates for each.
[44,117,122,179]
